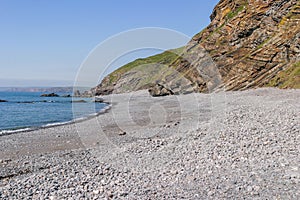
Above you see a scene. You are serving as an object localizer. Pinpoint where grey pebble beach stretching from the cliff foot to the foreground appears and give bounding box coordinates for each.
[0,88,300,200]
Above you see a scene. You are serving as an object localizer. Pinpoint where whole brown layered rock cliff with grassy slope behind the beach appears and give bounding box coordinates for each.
[94,0,300,94]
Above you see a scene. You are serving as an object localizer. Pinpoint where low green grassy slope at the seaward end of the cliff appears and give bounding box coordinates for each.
[95,47,184,94]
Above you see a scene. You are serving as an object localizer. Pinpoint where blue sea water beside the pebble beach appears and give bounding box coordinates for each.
[0,92,107,135]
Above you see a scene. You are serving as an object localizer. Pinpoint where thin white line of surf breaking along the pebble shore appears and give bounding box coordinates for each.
[0,104,112,136]
